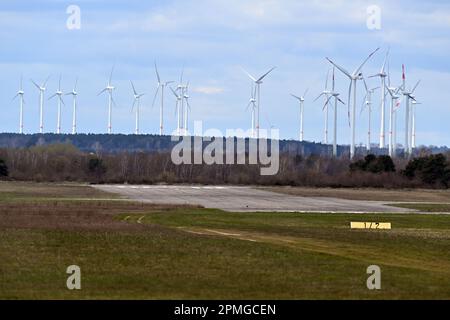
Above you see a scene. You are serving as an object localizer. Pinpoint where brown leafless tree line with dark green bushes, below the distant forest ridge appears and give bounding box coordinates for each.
[0,143,450,188]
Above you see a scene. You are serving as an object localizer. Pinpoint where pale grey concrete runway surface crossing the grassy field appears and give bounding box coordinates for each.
[94,185,414,213]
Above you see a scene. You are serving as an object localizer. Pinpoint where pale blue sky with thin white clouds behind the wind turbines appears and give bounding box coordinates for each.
[0,0,450,146]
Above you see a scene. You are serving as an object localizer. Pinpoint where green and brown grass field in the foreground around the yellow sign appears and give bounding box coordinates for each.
[0,183,450,299]
